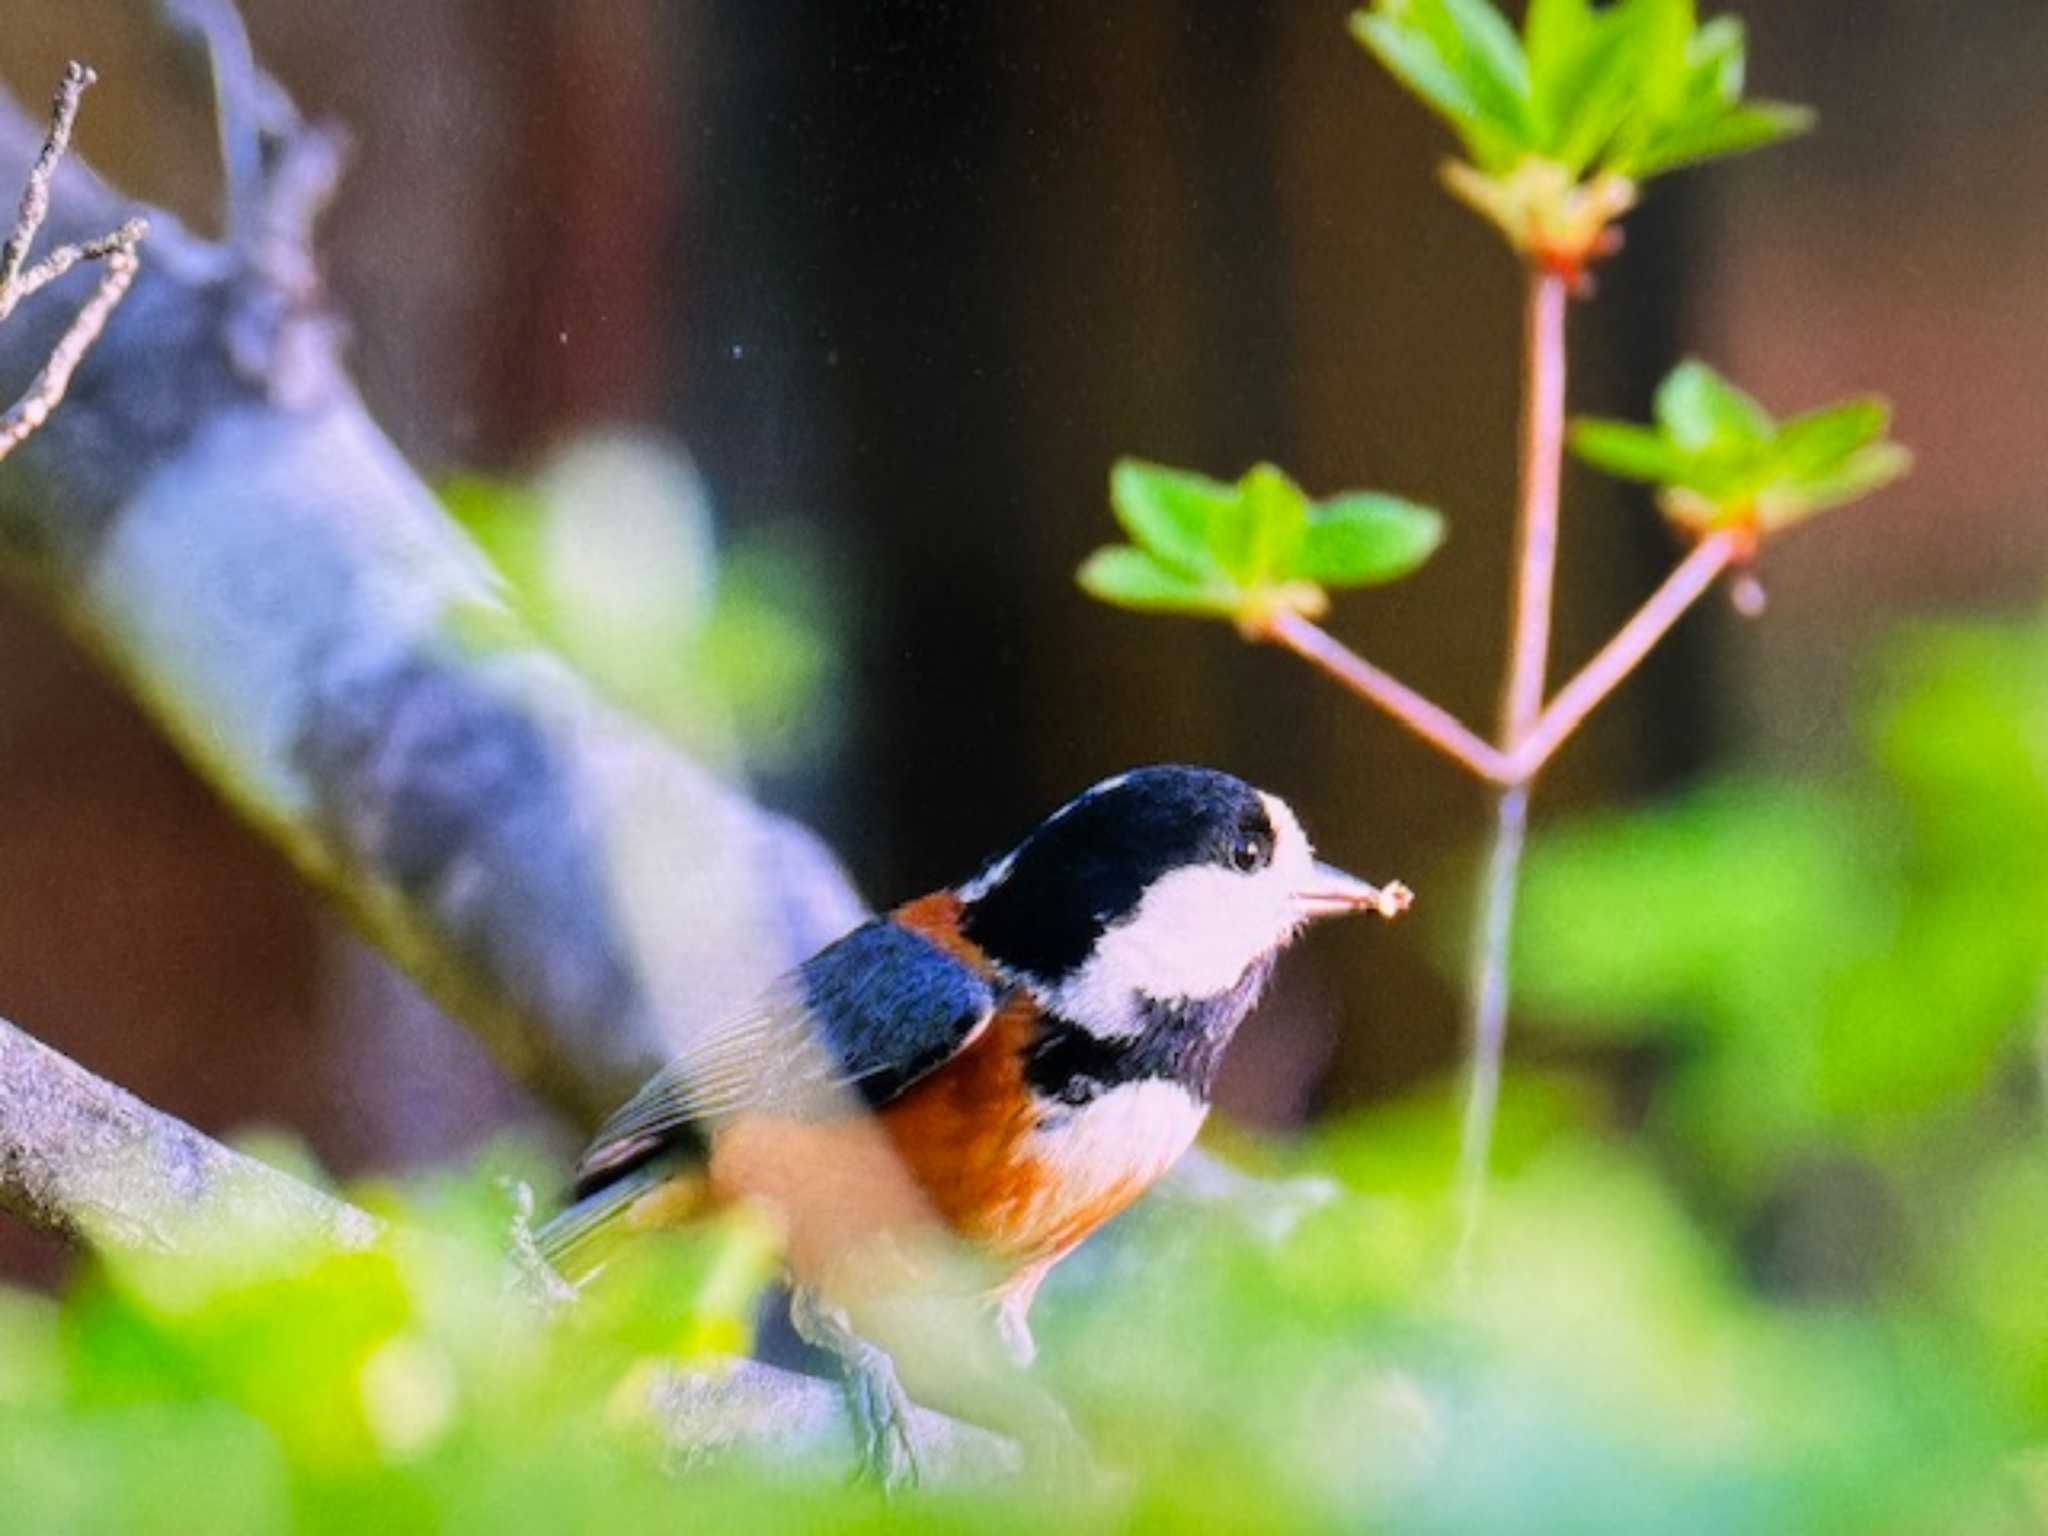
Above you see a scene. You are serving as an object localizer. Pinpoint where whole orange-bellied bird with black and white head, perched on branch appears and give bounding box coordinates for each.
[541,766,1409,1481]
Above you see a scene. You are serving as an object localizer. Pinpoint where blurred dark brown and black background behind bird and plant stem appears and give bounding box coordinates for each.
[0,0,2048,1272]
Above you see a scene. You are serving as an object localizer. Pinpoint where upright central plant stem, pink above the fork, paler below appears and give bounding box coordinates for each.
[1456,266,1571,1276]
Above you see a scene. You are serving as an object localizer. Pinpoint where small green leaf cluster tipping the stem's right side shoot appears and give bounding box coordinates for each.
[1571,360,1913,535]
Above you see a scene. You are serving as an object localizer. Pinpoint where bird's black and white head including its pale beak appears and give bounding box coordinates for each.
[961,766,1386,1012]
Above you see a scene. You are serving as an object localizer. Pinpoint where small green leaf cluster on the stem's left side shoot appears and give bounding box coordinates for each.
[1079,459,1444,629]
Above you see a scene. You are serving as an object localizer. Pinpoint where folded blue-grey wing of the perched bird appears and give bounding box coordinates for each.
[575,918,995,1196]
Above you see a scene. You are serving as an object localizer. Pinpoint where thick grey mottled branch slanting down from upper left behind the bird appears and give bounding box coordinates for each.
[0,93,862,1120]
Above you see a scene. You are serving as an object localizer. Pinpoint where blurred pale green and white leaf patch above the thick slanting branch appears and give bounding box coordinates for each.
[440,436,836,770]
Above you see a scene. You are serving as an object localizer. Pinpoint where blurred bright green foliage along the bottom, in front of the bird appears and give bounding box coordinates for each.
[0,1079,2048,1536]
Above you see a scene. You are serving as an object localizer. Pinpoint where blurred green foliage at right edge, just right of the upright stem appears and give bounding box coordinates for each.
[1518,610,2048,1179]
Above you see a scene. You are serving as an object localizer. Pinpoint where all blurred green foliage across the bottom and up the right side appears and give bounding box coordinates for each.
[0,606,2048,1536]
